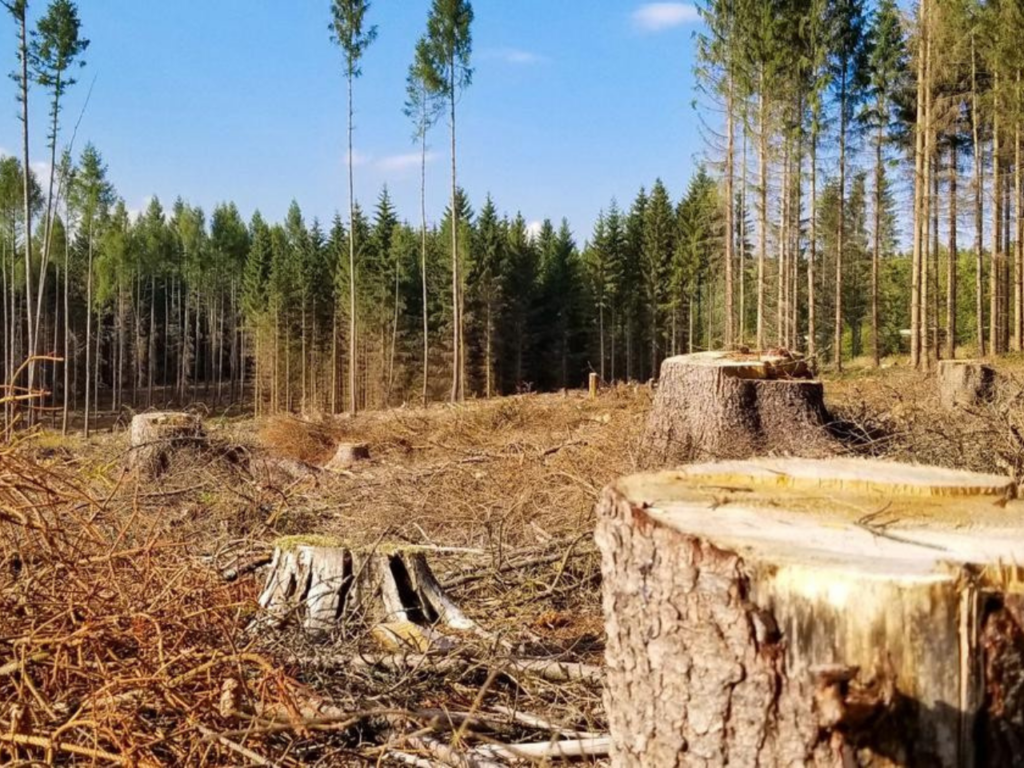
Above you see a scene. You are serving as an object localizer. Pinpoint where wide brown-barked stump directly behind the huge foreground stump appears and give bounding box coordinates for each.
[641,350,840,469]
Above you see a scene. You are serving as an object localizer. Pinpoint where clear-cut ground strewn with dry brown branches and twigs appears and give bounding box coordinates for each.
[0,360,1024,766]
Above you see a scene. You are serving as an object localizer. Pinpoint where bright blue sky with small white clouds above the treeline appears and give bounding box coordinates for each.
[0,0,701,243]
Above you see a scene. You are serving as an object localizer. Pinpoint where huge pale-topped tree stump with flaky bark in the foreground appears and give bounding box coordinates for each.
[596,459,1024,768]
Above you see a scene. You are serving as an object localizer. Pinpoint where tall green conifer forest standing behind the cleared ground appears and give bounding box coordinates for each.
[0,0,1024,429]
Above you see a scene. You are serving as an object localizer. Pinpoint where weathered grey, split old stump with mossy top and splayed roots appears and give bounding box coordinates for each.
[259,536,477,638]
